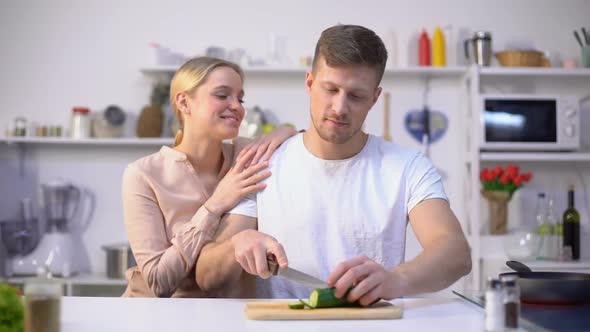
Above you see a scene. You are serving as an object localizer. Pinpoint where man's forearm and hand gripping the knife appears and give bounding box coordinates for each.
[196,214,287,291]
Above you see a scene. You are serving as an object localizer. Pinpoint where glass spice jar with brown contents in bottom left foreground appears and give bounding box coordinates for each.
[24,273,62,332]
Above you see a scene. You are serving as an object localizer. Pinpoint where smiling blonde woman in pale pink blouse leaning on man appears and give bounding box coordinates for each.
[123,57,295,297]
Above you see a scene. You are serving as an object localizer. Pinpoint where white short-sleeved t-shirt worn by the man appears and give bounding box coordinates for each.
[229,134,448,298]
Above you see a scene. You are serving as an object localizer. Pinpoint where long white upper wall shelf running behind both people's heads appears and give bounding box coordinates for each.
[140,66,468,78]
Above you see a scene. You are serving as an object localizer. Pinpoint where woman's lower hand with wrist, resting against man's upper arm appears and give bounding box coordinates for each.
[204,149,270,217]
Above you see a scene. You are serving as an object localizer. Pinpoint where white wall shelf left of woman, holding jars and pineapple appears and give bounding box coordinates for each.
[0,137,174,146]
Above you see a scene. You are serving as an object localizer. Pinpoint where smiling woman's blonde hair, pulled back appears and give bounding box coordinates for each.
[170,56,244,146]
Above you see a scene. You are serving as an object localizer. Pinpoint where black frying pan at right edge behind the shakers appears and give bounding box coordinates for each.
[500,261,590,305]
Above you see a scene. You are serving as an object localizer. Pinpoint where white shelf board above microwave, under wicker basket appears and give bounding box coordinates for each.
[478,67,590,79]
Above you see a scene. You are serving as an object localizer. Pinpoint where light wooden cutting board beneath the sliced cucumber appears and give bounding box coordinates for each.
[246,300,403,320]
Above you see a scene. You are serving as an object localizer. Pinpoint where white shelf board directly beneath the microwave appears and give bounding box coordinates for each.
[480,152,590,162]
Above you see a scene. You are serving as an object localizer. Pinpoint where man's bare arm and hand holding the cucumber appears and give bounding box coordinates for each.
[327,199,471,305]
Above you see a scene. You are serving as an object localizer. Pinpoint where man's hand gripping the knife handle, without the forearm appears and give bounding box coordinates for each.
[231,229,288,279]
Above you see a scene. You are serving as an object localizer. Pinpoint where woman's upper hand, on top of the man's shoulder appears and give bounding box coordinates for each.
[237,126,297,165]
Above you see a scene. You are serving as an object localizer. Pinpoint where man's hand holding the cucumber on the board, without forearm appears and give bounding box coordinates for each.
[327,256,410,306]
